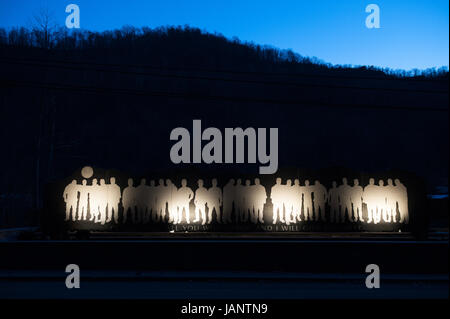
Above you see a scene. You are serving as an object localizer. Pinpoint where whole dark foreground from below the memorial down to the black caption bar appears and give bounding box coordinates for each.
[0,239,449,299]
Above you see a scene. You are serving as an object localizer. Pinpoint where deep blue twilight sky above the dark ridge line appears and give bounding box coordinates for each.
[0,0,449,70]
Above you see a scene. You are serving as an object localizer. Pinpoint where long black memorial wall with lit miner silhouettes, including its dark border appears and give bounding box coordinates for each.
[45,166,424,232]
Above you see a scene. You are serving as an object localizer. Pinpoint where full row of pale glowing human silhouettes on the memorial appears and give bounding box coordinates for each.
[63,169,409,225]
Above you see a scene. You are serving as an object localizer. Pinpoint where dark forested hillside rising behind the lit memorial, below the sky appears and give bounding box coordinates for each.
[0,28,449,205]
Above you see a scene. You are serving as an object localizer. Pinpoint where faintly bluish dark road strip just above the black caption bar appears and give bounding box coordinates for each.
[0,271,449,299]
